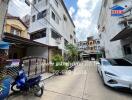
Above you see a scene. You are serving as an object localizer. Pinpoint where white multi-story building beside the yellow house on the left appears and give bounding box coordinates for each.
[29,0,76,60]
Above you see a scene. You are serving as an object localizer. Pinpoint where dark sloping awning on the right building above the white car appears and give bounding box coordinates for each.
[110,28,132,41]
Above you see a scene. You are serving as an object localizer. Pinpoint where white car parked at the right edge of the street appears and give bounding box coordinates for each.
[97,58,132,90]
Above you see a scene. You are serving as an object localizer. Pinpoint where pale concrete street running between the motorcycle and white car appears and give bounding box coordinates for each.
[9,61,132,100]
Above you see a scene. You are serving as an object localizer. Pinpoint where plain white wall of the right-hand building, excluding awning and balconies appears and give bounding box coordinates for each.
[98,0,123,58]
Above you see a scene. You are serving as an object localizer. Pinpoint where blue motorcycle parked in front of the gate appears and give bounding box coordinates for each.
[11,70,44,97]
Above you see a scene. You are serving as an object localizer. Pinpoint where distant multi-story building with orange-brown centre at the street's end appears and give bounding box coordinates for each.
[77,36,102,60]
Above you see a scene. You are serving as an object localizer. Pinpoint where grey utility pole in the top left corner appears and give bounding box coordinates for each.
[0,0,9,40]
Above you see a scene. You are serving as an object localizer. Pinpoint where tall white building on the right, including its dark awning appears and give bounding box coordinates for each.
[98,0,132,59]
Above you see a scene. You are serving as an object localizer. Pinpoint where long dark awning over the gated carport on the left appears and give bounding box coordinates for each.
[3,33,48,47]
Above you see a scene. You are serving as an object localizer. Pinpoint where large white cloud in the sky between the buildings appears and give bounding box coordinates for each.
[74,0,101,40]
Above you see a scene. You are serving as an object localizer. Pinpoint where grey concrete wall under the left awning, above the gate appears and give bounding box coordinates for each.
[26,47,48,59]
